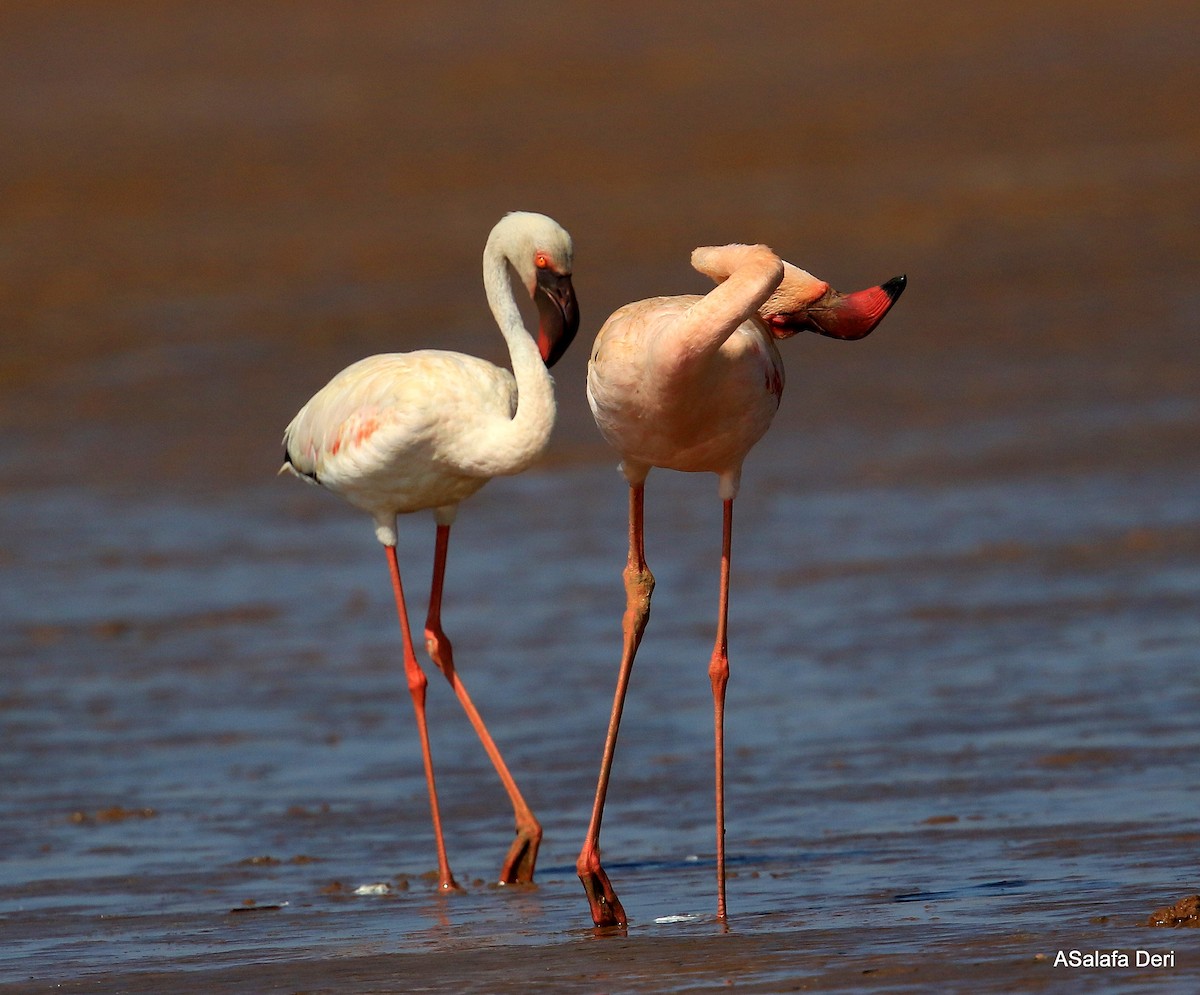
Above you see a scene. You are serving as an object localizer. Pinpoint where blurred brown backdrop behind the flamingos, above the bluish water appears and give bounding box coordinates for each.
[0,0,1200,488]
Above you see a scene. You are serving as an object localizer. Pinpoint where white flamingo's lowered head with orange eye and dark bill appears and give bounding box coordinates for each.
[493,211,580,366]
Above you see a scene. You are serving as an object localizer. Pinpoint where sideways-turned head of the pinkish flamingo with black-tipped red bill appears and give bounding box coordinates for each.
[758,263,908,340]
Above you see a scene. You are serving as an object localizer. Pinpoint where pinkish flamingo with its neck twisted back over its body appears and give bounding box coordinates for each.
[576,245,906,925]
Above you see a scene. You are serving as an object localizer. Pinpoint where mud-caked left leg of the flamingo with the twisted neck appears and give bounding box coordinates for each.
[575,484,654,925]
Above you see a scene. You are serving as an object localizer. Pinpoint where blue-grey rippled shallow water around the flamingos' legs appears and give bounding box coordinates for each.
[0,466,1200,990]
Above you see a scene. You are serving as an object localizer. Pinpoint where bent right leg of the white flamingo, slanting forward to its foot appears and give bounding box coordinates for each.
[425,525,541,885]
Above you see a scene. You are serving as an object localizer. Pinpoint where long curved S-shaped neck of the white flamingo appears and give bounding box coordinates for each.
[468,241,557,475]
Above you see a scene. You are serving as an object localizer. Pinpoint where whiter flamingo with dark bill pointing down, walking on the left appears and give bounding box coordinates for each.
[281,211,580,891]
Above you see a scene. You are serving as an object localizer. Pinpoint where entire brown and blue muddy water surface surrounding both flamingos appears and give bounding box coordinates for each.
[0,0,1200,993]
